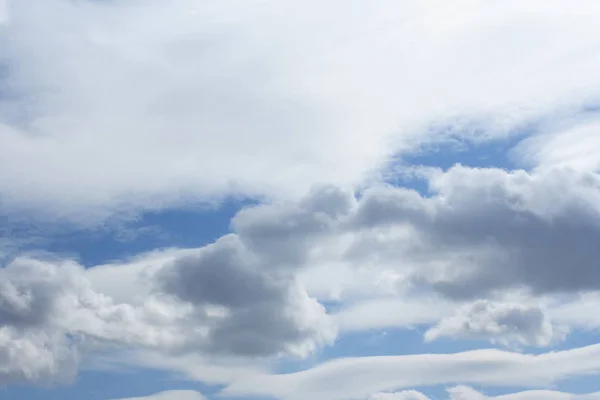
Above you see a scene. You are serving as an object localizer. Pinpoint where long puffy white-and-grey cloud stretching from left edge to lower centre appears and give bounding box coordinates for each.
[0,250,336,382]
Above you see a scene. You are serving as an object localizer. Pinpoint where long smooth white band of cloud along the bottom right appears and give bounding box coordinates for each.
[222,345,600,400]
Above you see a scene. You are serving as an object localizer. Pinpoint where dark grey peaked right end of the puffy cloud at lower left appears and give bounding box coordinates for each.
[157,235,335,356]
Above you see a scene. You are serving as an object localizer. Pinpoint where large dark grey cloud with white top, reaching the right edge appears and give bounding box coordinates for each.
[304,165,600,301]
